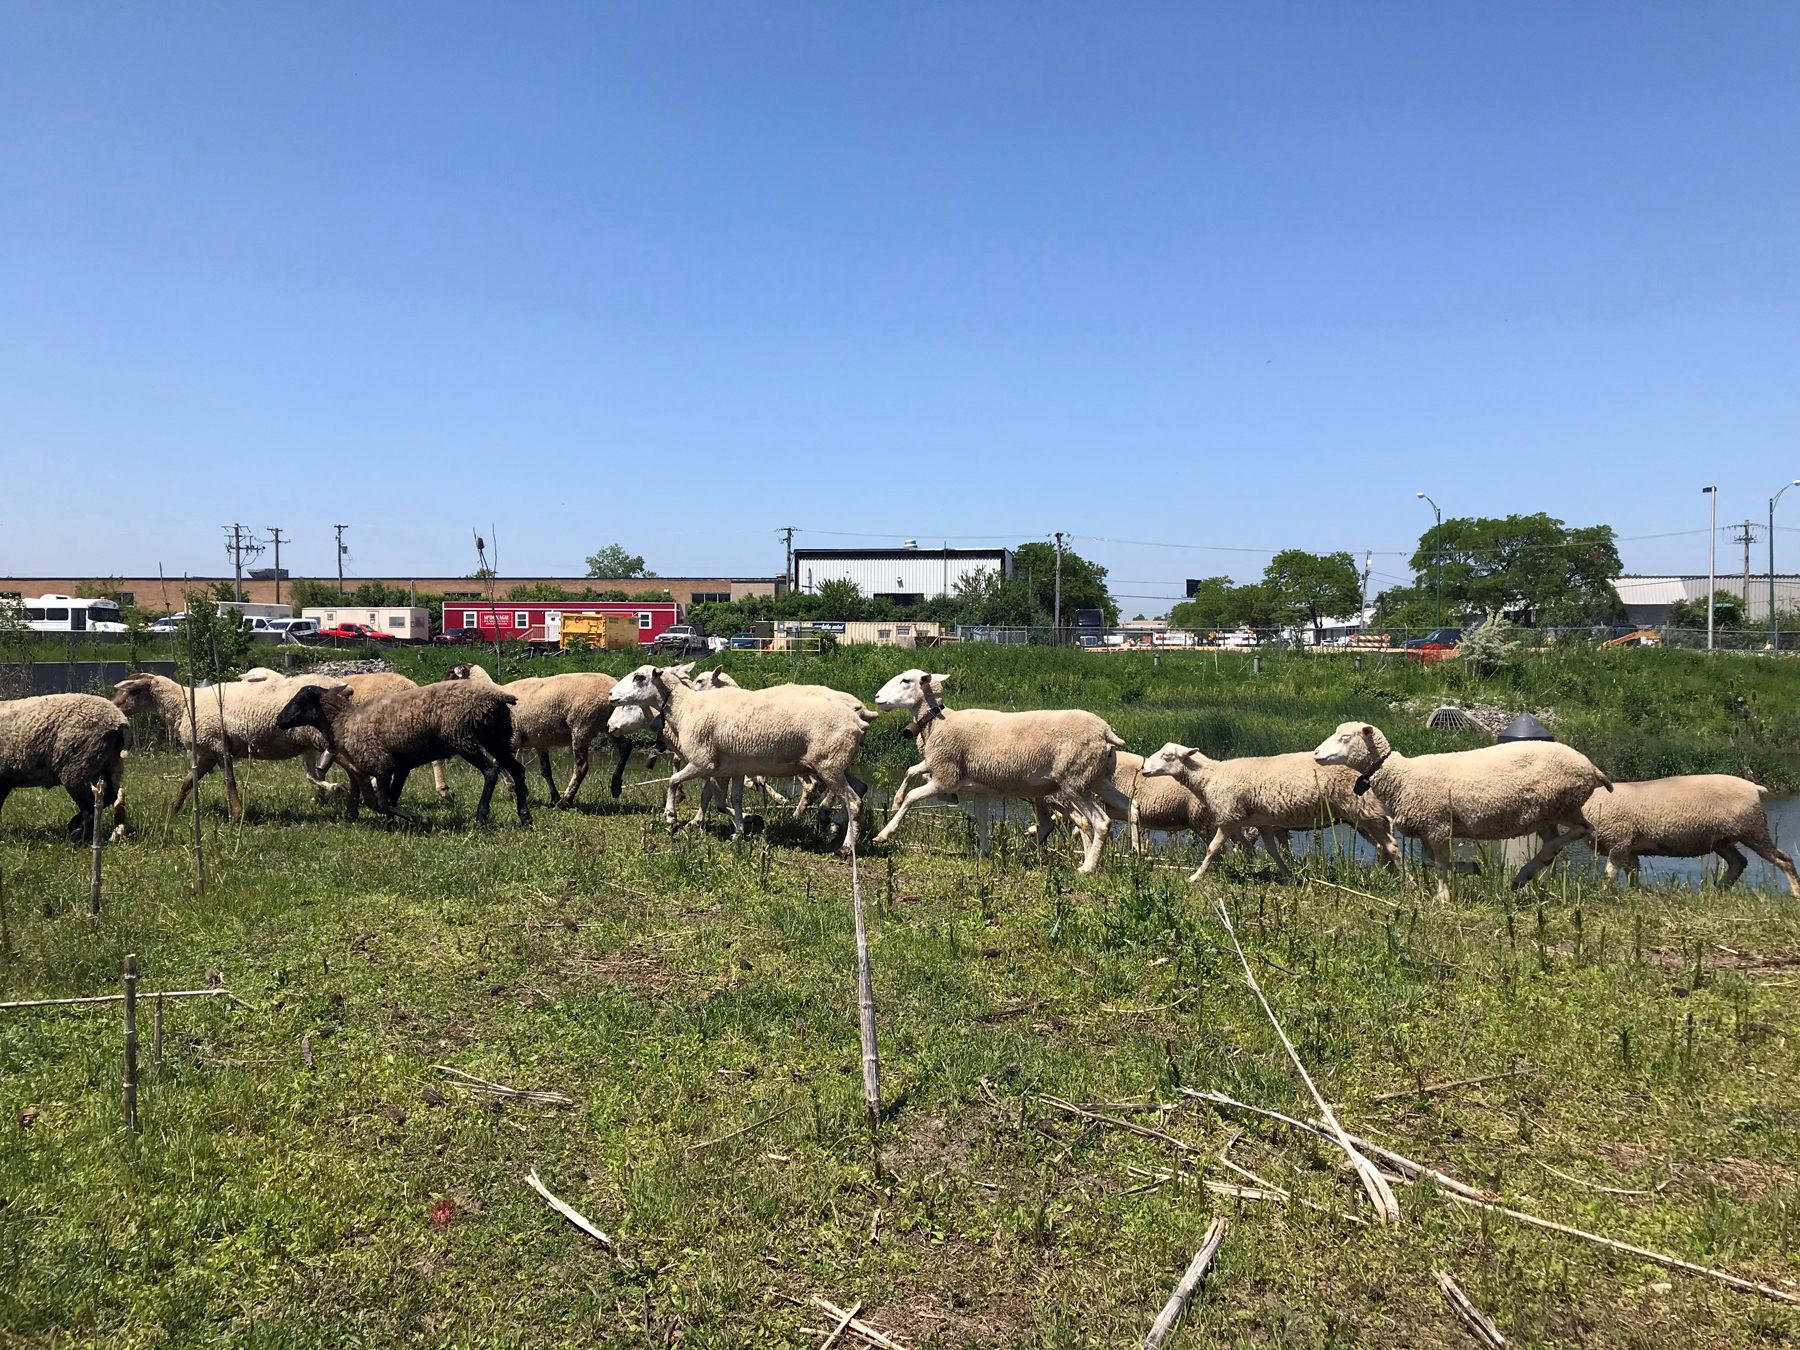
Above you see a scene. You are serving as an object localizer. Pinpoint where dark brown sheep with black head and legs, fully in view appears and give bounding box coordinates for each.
[275,680,531,824]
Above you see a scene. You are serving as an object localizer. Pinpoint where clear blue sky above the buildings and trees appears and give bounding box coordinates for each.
[0,0,1800,614]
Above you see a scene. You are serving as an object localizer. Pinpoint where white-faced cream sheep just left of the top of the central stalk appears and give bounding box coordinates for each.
[612,666,868,853]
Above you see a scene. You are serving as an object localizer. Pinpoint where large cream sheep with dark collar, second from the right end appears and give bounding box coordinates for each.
[1312,722,1613,904]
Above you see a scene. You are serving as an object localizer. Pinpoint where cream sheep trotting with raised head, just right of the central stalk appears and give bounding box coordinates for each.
[875,670,1130,873]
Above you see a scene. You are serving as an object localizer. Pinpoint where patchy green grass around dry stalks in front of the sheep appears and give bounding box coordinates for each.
[0,653,1800,1346]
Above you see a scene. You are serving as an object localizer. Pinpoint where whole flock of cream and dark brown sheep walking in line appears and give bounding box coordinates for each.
[0,664,1800,900]
